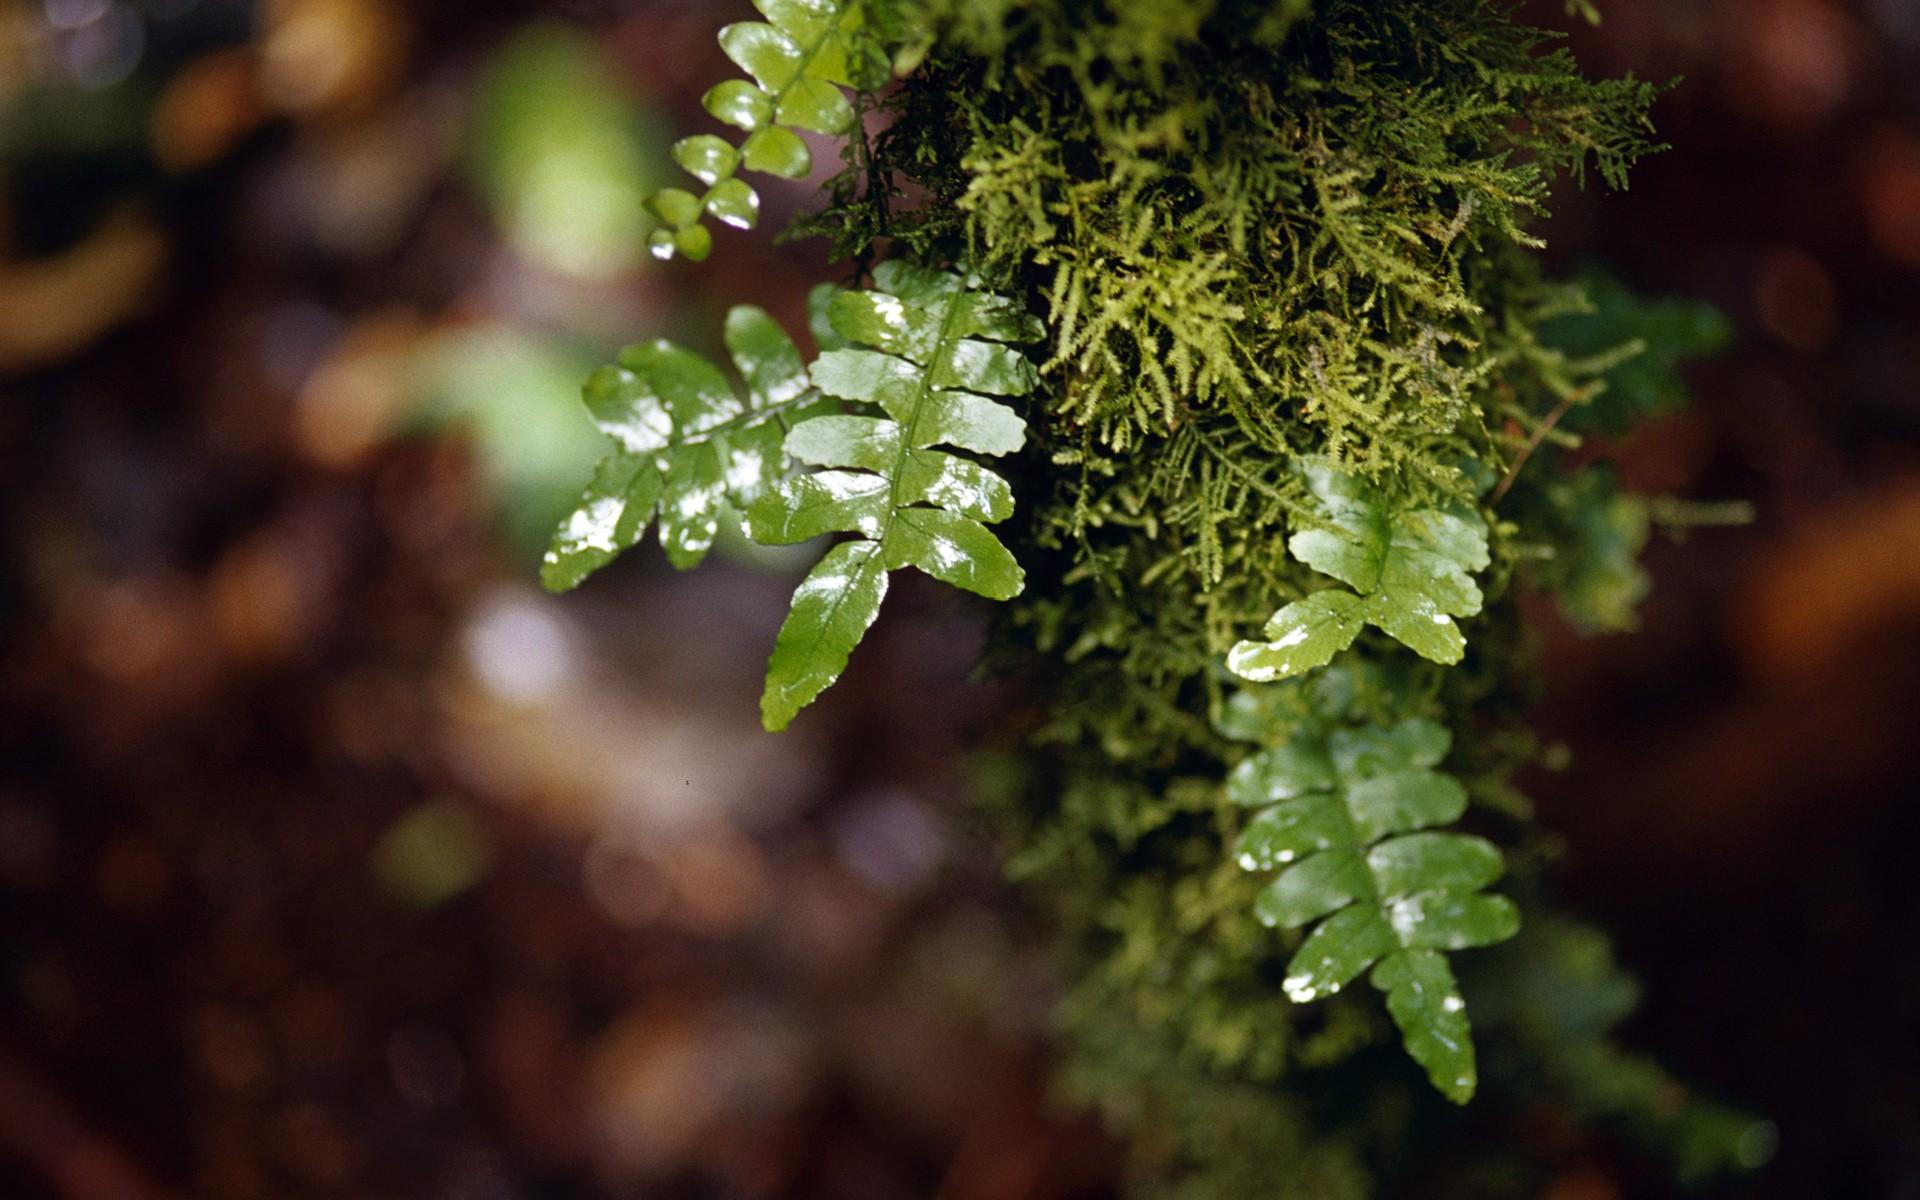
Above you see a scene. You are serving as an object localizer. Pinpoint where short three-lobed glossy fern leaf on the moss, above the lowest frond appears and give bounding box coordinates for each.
[1227,465,1488,684]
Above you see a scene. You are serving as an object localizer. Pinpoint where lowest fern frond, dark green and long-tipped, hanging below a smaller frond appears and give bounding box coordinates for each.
[1223,702,1519,1104]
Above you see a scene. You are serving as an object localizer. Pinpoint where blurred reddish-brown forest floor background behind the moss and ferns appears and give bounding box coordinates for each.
[0,0,1920,1200]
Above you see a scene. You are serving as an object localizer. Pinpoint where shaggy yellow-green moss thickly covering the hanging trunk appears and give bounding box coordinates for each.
[549,0,1751,1198]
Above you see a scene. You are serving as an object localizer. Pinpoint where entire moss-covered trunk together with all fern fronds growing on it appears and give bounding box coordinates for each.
[545,0,1738,1198]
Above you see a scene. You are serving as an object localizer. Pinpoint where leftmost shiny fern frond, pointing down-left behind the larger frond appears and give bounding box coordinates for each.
[540,305,820,591]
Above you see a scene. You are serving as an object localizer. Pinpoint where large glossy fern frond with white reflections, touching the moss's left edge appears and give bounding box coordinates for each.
[747,261,1043,730]
